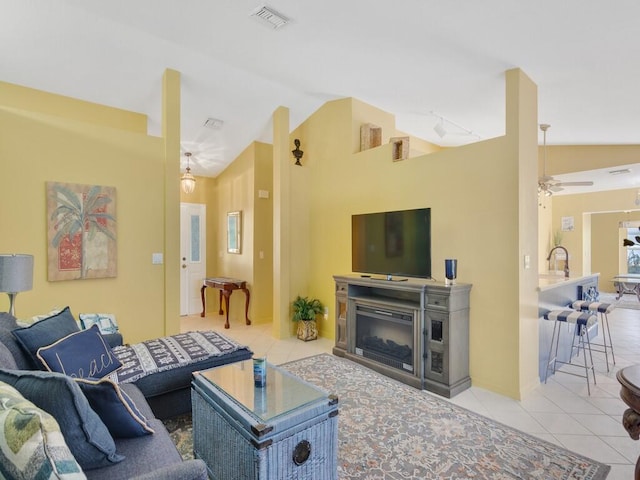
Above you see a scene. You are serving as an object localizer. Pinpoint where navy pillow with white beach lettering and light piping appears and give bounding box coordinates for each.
[36,325,122,378]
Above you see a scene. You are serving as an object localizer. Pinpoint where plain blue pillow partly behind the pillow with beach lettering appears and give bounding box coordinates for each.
[12,307,80,370]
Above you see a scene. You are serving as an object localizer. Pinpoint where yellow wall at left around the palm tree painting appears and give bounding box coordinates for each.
[0,79,178,342]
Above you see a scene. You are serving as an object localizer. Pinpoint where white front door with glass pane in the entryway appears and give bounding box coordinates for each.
[180,203,207,315]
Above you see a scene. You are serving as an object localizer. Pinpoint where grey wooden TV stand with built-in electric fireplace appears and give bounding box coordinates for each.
[333,275,471,398]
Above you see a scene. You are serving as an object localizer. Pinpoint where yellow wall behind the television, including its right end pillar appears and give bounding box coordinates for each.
[270,71,538,398]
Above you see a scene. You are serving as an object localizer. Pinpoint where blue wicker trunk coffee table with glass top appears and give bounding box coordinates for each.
[191,360,338,480]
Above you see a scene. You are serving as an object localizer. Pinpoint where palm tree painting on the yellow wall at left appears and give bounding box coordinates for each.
[47,182,117,281]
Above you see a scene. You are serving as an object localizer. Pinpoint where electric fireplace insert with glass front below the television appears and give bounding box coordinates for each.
[355,305,415,373]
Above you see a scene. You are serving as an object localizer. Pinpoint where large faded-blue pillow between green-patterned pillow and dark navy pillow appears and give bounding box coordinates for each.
[0,370,124,470]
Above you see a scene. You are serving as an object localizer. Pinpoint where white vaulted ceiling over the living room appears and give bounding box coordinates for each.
[0,0,640,193]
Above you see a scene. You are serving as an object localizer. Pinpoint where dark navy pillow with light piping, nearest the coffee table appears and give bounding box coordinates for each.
[76,378,154,438]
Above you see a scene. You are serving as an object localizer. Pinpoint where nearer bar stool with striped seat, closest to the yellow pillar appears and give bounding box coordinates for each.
[544,310,598,395]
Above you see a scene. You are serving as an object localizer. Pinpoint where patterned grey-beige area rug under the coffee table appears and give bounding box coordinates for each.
[167,354,610,480]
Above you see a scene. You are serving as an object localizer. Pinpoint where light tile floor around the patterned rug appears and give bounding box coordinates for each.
[181,308,640,480]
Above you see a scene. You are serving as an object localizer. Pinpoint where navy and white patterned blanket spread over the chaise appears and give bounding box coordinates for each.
[113,331,247,383]
